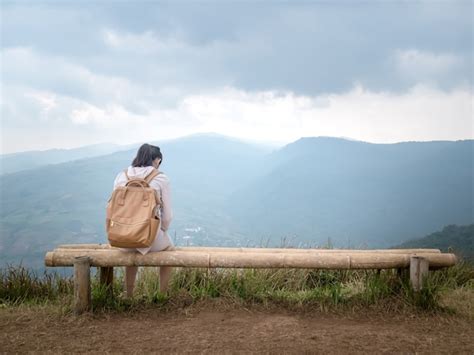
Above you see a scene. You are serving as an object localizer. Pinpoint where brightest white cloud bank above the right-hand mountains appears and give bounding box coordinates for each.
[176,86,474,143]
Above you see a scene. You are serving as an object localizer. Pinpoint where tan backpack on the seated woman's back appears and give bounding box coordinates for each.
[106,169,160,248]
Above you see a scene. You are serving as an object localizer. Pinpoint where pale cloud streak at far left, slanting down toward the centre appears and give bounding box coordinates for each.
[0,47,180,113]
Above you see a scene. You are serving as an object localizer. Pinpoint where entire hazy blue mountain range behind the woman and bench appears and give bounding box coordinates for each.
[0,134,474,266]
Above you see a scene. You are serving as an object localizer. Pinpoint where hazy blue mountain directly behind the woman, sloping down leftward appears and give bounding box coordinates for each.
[0,135,269,267]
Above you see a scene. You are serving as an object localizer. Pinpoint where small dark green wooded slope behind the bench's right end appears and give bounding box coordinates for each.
[398,224,474,261]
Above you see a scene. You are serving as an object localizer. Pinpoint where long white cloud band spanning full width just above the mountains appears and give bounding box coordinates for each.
[2,76,474,153]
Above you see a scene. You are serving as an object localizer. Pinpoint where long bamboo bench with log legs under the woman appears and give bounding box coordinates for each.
[45,244,457,314]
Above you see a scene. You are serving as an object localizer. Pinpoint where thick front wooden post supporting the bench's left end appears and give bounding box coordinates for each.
[74,256,91,314]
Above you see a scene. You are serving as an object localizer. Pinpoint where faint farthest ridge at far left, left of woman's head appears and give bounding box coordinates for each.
[0,143,130,174]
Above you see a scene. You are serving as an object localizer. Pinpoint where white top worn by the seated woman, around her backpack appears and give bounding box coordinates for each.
[114,166,173,254]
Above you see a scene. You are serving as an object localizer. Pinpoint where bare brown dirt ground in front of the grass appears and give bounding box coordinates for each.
[0,306,474,354]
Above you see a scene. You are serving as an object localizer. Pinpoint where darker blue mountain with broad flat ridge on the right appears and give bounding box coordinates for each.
[229,137,474,247]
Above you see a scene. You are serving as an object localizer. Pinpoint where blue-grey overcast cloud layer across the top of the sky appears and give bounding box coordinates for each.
[1,2,472,95]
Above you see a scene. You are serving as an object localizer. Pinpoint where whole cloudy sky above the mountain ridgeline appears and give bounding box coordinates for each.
[0,0,474,154]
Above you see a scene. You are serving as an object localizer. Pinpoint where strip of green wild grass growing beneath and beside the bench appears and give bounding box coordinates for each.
[0,262,474,314]
